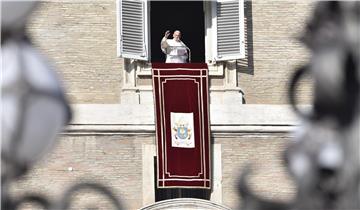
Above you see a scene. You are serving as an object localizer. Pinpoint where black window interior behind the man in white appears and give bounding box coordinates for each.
[150,1,205,63]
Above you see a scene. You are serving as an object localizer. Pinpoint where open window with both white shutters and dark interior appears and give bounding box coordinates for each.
[117,0,245,62]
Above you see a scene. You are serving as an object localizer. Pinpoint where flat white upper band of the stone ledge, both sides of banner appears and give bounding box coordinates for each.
[71,104,300,126]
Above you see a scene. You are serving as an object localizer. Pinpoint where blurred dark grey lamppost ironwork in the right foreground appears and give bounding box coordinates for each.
[239,1,360,210]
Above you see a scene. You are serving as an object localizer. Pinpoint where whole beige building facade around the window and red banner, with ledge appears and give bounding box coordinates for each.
[14,0,313,209]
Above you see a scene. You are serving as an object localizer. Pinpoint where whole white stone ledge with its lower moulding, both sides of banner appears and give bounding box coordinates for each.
[63,104,304,137]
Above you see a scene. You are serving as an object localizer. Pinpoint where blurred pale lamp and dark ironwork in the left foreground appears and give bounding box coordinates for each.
[1,0,122,210]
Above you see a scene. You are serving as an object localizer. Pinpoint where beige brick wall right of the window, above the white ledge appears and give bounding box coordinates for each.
[238,0,313,104]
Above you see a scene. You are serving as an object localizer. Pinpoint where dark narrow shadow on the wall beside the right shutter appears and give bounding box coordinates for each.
[236,1,254,75]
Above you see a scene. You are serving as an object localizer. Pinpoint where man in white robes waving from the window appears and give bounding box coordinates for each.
[161,31,188,63]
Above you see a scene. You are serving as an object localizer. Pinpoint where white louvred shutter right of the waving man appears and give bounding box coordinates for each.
[212,0,245,61]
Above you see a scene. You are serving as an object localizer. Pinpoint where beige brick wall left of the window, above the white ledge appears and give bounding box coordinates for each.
[29,0,123,103]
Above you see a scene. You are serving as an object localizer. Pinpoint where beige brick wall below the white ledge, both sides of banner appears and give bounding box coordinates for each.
[13,133,294,210]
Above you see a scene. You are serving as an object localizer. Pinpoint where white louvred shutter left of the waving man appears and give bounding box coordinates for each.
[117,0,149,60]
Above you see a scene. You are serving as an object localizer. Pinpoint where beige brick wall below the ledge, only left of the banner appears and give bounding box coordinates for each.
[14,135,154,210]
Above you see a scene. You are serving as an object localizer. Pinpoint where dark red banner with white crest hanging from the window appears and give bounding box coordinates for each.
[152,63,211,189]
